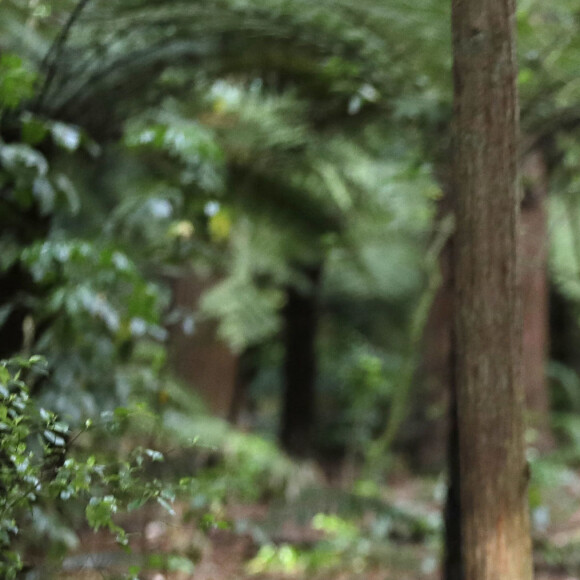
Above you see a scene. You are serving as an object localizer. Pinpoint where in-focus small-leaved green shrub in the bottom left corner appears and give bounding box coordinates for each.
[0,356,175,580]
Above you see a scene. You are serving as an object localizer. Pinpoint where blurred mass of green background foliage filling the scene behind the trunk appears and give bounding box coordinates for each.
[0,0,580,577]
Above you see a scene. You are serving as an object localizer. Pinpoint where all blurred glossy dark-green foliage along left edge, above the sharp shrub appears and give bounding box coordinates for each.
[0,84,172,425]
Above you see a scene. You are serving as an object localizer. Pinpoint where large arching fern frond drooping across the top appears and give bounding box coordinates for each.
[30,0,447,136]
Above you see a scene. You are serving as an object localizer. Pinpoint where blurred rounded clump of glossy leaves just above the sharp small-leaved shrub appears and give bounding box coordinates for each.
[7,239,166,423]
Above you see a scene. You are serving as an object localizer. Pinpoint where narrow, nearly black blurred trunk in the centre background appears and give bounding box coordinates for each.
[280,265,322,455]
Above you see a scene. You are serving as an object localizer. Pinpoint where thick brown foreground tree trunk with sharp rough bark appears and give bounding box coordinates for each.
[452,0,532,580]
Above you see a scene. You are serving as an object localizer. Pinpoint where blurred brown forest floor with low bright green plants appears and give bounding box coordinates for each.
[57,458,580,580]
